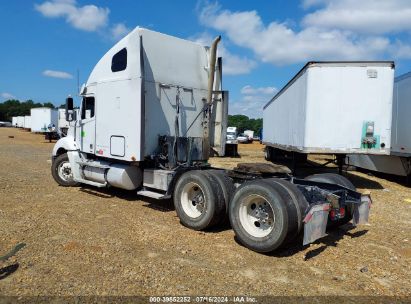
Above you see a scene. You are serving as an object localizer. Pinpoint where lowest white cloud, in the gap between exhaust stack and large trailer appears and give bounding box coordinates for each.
[229,85,278,118]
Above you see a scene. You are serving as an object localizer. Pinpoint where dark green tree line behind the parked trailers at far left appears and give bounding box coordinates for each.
[0,99,55,121]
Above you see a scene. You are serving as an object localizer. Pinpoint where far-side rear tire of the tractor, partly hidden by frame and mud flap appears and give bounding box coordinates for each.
[305,173,357,228]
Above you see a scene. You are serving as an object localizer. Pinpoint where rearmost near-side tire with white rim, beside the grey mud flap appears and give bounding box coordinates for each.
[229,180,297,252]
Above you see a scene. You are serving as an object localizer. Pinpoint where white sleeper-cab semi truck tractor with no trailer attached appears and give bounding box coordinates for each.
[51,28,371,252]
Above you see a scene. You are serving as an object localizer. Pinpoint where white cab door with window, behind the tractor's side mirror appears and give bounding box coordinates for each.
[78,95,96,154]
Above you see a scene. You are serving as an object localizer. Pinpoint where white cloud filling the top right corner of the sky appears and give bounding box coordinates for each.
[302,0,411,34]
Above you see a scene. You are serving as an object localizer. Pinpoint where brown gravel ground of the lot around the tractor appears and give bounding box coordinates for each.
[0,128,411,296]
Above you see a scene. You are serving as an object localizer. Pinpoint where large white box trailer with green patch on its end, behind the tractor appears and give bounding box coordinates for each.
[263,61,394,173]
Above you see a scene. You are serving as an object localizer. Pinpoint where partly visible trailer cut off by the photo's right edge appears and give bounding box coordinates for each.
[346,72,411,176]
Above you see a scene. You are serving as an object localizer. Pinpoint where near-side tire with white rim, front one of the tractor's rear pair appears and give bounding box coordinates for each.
[173,170,225,230]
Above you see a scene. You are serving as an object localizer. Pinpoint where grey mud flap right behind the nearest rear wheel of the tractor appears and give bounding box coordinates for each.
[303,203,330,245]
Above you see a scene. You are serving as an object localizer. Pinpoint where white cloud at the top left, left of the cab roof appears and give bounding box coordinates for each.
[35,0,110,32]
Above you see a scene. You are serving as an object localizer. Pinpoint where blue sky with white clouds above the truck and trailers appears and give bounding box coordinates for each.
[0,0,411,117]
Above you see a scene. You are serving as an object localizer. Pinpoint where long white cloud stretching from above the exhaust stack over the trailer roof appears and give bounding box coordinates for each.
[200,4,396,65]
